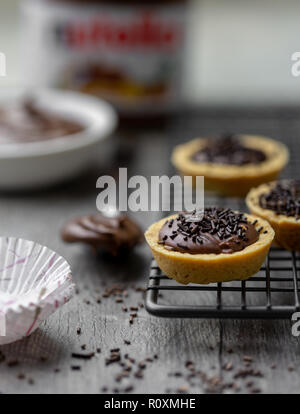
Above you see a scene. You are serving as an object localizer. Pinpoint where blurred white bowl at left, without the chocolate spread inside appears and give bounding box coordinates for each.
[0,89,117,190]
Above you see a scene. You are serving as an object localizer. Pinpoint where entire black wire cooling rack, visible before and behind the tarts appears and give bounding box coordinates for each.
[146,109,300,319]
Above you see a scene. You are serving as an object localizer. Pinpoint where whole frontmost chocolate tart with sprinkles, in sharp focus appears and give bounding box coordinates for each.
[145,207,274,285]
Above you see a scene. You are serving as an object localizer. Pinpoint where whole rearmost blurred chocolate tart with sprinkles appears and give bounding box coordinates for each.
[172,135,289,197]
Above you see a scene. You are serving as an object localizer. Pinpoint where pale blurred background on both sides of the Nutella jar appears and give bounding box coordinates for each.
[0,0,300,106]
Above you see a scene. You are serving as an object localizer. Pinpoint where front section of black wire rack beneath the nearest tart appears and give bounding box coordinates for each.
[146,248,300,319]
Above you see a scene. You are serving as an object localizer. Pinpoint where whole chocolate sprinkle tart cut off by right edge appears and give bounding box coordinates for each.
[246,180,300,251]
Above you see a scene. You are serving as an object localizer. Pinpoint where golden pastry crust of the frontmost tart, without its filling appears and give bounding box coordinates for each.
[145,214,274,285]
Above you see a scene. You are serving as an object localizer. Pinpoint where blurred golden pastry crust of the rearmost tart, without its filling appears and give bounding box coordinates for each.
[172,135,289,196]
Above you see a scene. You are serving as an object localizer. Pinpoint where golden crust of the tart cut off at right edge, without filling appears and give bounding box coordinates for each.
[246,182,300,251]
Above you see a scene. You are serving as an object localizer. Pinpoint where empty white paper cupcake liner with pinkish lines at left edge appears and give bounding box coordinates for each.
[0,237,75,345]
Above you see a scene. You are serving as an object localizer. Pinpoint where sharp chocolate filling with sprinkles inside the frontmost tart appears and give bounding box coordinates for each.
[159,207,262,254]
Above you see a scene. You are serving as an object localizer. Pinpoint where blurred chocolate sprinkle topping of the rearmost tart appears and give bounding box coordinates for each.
[192,135,266,165]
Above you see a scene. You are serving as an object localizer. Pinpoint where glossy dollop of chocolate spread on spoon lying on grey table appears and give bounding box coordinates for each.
[62,213,144,256]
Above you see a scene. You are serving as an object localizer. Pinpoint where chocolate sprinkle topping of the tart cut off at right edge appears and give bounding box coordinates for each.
[259,180,300,219]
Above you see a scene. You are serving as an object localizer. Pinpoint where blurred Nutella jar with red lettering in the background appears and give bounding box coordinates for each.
[22,0,187,116]
